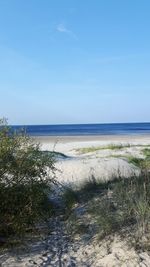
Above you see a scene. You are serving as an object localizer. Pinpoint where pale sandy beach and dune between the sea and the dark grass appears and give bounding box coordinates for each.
[34,135,150,187]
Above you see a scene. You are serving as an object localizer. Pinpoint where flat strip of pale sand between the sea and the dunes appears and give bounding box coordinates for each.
[33,134,150,153]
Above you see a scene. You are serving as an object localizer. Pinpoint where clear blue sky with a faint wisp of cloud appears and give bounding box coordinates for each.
[0,0,150,124]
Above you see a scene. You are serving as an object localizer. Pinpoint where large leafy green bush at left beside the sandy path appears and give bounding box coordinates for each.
[0,120,55,241]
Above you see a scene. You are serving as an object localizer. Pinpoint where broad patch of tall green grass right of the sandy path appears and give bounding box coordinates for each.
[66,170,150,246]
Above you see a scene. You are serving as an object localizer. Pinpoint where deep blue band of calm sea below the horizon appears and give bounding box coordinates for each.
[13,123,150,136]
